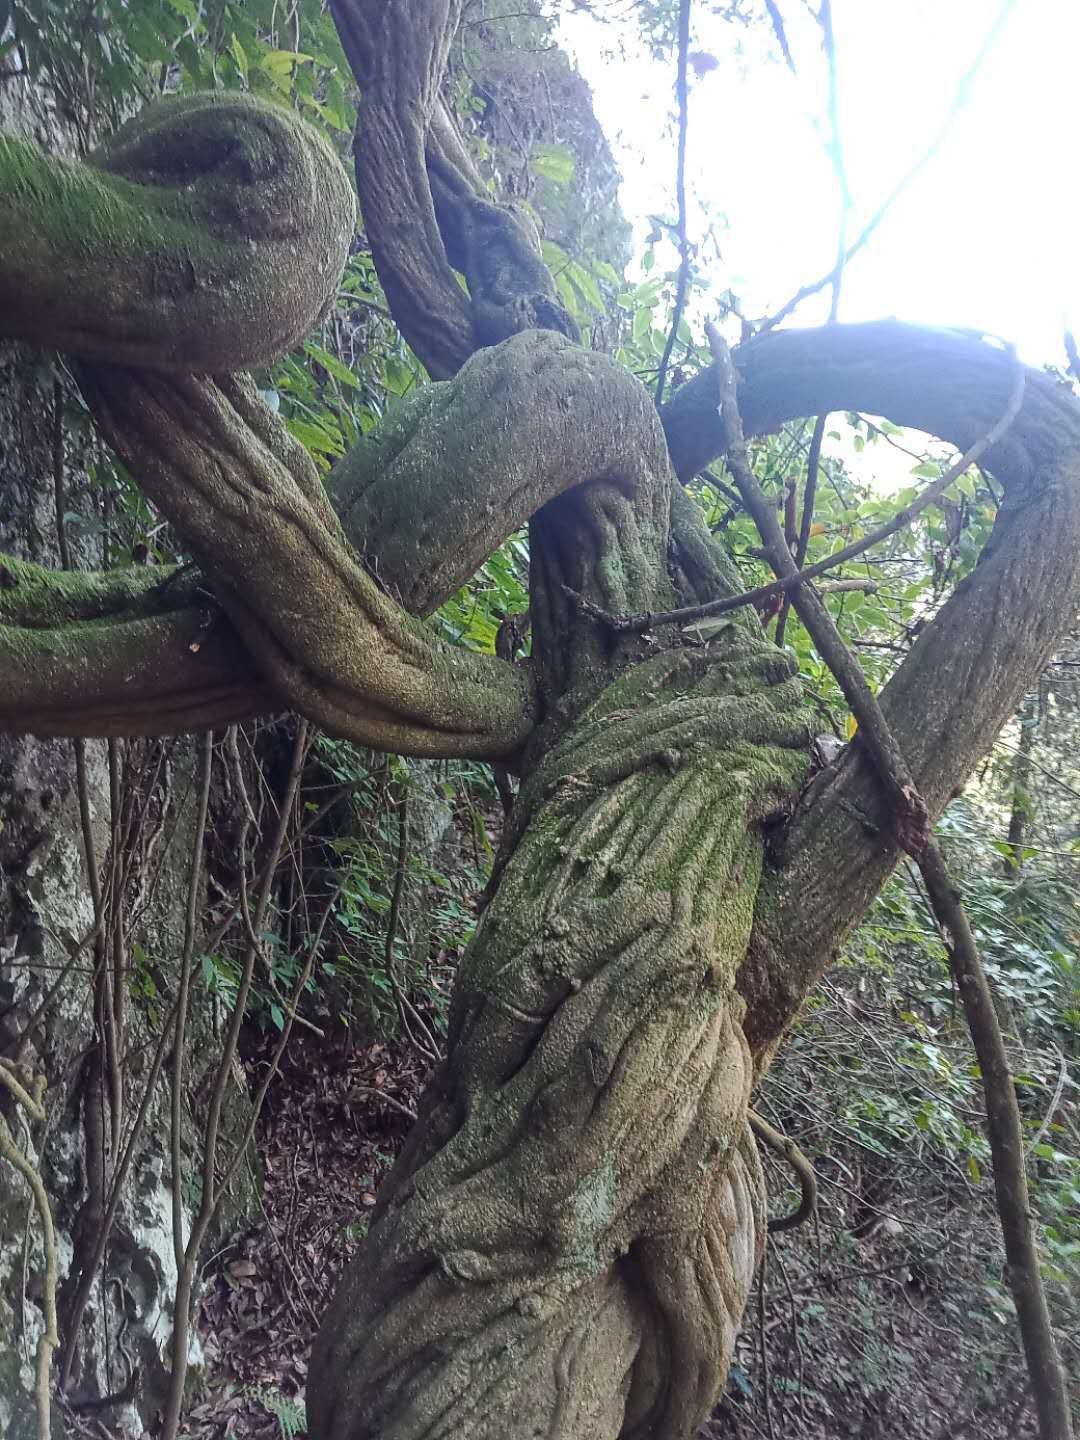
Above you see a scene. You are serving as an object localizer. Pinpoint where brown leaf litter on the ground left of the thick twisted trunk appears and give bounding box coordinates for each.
[184,1032,426,1440]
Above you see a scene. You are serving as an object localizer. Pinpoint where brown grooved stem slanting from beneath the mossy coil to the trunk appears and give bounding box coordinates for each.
[74,366,533,755]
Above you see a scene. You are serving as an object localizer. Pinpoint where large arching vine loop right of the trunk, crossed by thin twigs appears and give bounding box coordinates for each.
[705,323,1080,1064]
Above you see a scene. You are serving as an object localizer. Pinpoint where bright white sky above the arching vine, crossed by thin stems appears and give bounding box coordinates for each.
[562,0,1080,364]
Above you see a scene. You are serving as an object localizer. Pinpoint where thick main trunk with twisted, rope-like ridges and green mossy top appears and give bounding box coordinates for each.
[308,642,809,1440]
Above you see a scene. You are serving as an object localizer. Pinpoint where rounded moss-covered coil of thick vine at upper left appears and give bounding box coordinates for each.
[0,95,356,373]
